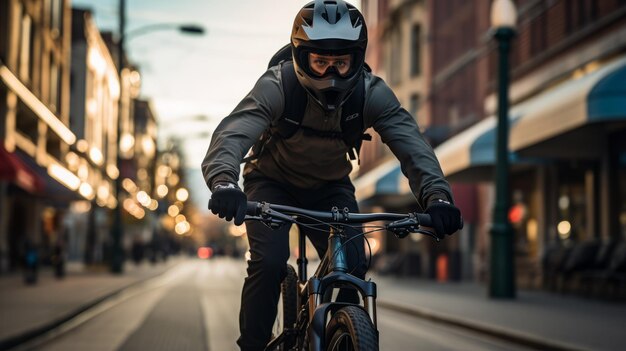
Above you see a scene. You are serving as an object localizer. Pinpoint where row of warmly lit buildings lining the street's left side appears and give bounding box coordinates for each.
[0,0,161,272]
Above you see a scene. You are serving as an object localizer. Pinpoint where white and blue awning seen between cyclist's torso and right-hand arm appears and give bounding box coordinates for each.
[354,158,413,207]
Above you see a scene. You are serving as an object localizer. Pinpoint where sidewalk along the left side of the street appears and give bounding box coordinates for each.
[0,257,181,350]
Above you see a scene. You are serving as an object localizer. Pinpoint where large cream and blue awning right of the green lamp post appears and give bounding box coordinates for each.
[509,57,626,156]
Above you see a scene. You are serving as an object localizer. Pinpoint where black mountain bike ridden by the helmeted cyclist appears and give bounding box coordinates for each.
[238,201,454,351]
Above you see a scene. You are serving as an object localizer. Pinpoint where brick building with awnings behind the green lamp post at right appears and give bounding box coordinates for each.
[432,1,626,288]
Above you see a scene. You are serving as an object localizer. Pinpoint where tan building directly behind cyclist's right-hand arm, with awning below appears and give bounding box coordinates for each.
[355,0,460,279]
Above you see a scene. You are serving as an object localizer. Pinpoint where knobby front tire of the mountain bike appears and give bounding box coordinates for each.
[326,306,378,351]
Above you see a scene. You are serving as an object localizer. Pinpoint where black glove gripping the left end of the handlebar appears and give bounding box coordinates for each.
[209,182,248,225]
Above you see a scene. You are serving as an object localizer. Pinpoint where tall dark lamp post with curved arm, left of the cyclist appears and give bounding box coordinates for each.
[110,0,204,274]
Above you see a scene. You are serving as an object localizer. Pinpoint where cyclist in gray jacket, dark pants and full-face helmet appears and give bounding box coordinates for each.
[202,0,461,350]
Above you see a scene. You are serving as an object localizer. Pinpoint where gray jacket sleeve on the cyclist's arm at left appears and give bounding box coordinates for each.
[202,68,284,188]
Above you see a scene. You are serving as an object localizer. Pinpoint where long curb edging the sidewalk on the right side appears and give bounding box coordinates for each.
[376,299,588,351]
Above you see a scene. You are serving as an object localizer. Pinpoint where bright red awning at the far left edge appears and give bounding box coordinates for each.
[0,141,44,194]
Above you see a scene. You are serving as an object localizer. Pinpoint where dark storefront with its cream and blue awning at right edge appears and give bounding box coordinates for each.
[510,57,626,243]
